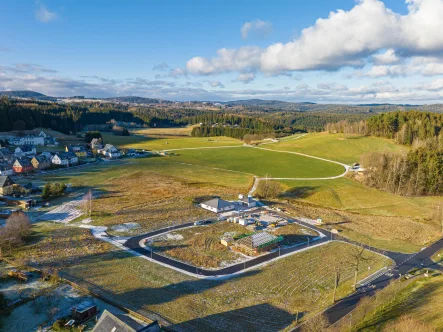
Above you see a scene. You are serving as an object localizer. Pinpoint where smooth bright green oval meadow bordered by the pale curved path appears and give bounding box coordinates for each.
[171,147,344,178]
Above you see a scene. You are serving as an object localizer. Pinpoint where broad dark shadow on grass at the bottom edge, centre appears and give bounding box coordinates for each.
[171,303,295,332]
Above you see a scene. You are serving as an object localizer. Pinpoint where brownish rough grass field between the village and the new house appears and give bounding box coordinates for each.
[45,157,252,235]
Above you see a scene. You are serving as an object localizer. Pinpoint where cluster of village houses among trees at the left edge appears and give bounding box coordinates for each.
[0,131,140,218]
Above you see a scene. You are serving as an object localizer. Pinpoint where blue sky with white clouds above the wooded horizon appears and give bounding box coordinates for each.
[0,0,443,104]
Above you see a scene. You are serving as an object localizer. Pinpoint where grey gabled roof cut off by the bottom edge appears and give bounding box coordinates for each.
[92,310,161,332]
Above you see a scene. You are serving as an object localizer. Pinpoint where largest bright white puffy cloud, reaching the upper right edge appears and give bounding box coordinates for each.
[187,0,443,75]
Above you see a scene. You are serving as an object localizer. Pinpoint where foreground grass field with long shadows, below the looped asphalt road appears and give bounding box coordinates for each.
[59,243,387,331]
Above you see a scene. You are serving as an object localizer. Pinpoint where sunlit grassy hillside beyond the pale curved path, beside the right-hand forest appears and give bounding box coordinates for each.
[266,133,407,165]
